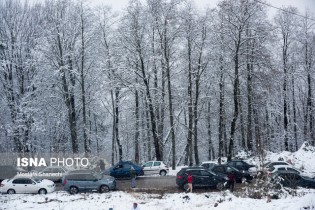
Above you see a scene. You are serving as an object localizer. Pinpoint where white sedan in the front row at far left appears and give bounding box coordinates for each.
[0,177,56,194]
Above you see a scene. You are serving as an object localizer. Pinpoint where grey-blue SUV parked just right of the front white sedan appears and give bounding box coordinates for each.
[62,172,116,194]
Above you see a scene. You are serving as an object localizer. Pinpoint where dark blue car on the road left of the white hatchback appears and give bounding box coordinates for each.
[104,161,144,178]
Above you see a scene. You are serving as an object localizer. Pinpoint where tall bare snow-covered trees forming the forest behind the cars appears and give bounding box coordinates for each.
[0,0,315,167]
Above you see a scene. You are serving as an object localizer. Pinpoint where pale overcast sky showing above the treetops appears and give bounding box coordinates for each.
[84,0,315,15]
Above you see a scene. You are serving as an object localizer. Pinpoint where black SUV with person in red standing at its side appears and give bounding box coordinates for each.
[176,167,227,190]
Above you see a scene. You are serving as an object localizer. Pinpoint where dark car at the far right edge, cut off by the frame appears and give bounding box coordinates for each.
[271,171,315,189]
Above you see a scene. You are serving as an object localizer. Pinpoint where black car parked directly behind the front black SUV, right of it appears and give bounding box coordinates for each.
[210,164,253,183]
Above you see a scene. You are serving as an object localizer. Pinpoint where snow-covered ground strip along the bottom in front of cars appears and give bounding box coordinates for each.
[0,190,315,210]
